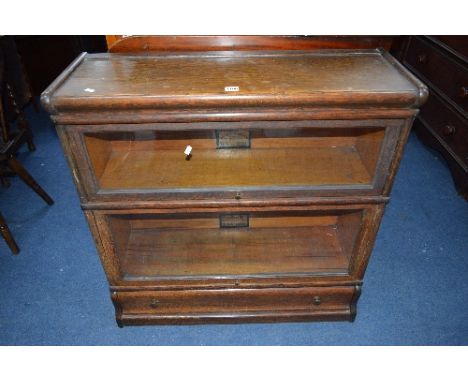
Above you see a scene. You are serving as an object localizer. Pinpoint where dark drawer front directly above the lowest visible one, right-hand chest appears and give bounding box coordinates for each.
[405,38,468,113]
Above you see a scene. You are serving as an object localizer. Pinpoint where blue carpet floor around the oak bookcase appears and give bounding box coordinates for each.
[0,102,468,345]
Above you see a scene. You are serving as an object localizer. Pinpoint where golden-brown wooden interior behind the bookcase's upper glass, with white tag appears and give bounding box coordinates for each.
[85,129,384,190]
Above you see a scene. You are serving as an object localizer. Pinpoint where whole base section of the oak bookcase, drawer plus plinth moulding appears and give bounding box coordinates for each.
[112,286,359,325]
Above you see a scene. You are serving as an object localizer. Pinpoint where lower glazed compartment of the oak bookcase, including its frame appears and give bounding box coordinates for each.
[87,205,383,286]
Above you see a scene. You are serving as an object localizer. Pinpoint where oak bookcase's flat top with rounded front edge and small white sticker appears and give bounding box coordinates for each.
[42,50,427,114]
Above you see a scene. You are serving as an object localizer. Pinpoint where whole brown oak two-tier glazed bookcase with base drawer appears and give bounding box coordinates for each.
[42,50,427,326]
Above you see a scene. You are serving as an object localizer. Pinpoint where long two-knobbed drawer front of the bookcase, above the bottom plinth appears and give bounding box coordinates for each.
[113,286,357,318]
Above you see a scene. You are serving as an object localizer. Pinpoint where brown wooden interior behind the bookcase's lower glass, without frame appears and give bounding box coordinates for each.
[106,212,361,279]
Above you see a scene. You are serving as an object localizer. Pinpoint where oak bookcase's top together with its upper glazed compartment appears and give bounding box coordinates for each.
[42,50,427,207]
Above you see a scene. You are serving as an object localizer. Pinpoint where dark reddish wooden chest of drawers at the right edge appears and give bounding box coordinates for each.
[401,36,468,199]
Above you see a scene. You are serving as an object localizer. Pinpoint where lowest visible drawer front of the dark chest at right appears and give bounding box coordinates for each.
[419,93,468,166]
